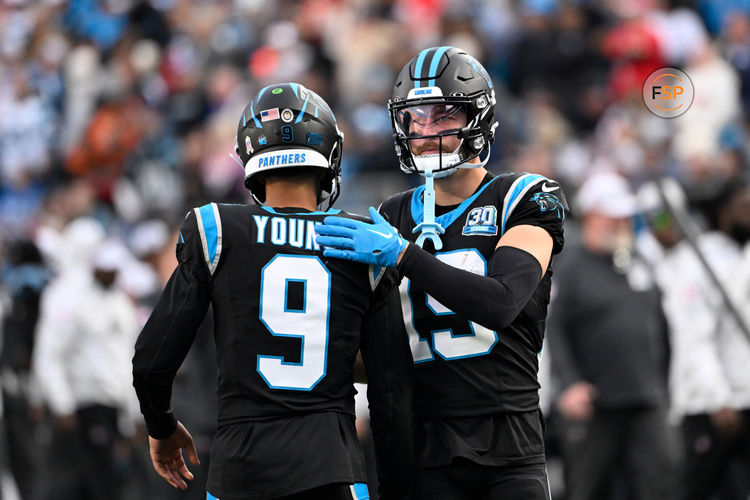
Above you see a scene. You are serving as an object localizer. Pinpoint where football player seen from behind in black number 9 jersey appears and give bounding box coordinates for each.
[133,83,412,500]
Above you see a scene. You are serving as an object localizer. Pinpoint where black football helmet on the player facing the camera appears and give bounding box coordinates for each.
[388,46,497,177]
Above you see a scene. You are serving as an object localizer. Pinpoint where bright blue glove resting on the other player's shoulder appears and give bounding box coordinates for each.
[315,207,408,267]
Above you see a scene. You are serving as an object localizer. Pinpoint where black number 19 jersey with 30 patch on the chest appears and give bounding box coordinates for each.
[380,174,567,418]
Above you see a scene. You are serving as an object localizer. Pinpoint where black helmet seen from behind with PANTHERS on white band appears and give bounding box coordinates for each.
[235,83,344,209]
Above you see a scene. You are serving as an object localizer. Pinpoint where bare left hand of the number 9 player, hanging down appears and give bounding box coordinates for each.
[148,422,200,490]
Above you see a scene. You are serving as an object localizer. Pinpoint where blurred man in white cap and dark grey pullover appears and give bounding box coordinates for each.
[547,173,676,500]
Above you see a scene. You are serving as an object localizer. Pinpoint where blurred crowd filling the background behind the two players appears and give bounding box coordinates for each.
[0,0,750,500]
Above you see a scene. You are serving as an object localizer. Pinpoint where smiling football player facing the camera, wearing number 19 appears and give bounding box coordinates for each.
[316,47,567,499]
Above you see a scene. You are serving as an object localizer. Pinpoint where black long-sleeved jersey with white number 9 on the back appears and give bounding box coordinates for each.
[133,203,411,498]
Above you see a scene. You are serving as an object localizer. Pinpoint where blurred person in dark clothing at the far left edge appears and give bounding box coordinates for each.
[0,240,49,500]
